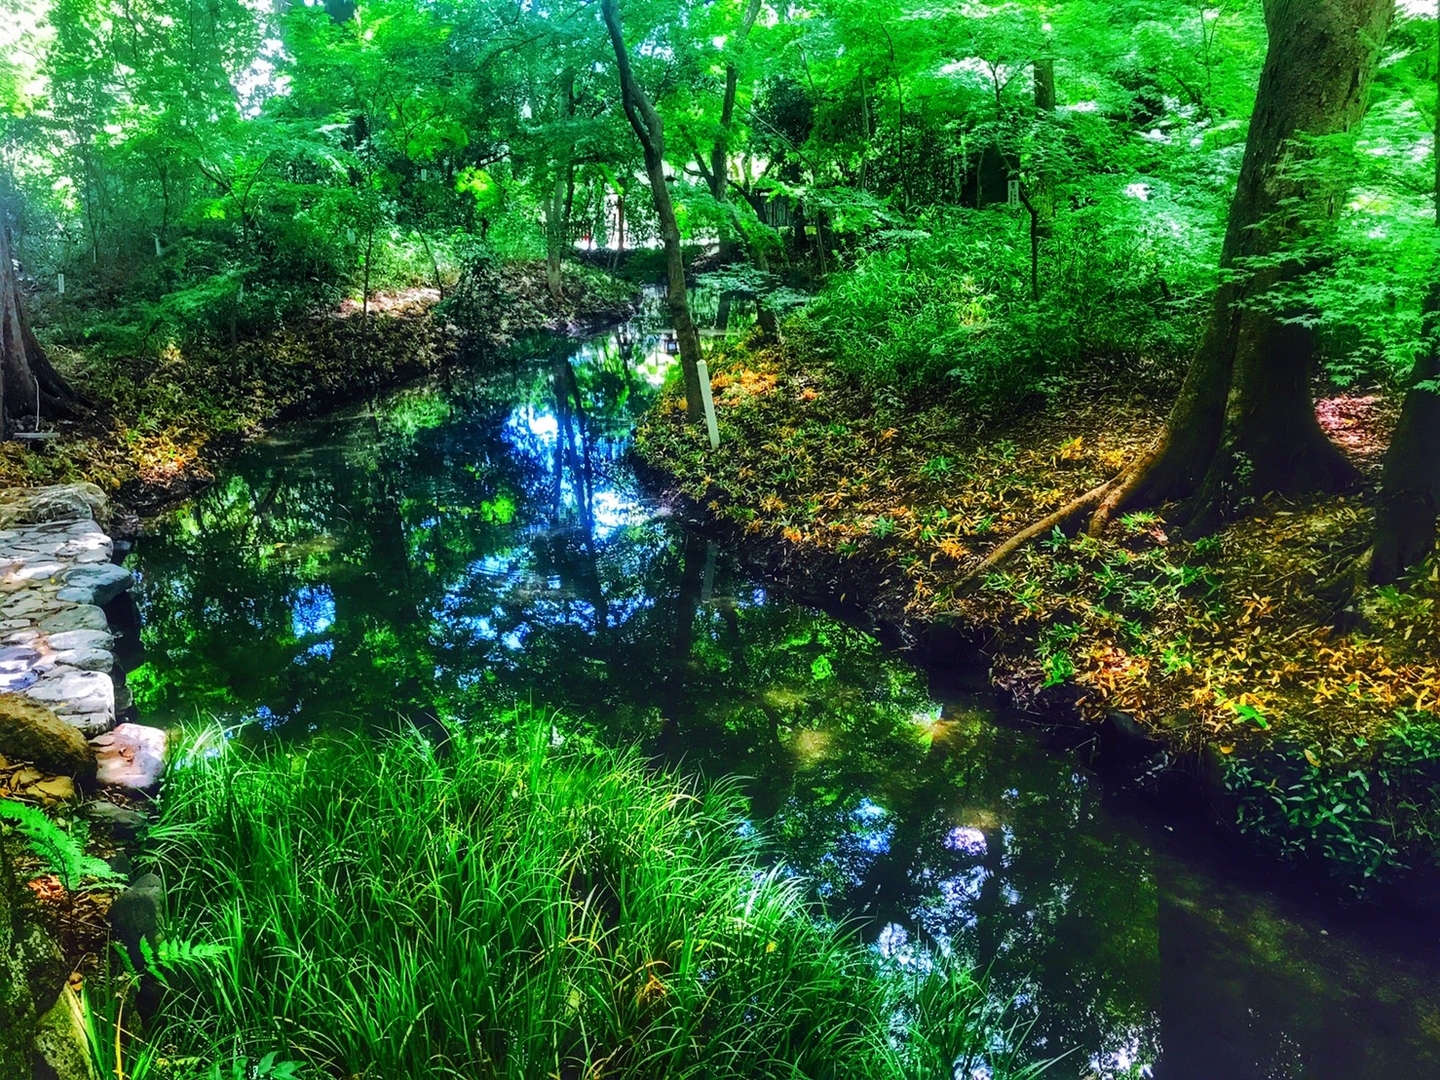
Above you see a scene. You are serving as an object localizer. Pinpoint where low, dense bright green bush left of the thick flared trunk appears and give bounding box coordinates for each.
[804,197,1204,410]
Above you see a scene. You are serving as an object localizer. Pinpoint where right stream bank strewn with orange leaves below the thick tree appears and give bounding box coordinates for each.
[635,334,1440,909]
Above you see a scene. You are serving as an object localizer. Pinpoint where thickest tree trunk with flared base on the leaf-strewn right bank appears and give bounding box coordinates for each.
[1092,0,1395,533]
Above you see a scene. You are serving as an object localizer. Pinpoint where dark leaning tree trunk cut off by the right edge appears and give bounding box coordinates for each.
[1369,14,1440,585]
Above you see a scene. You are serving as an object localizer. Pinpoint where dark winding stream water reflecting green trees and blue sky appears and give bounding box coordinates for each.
[130,308,1440,1080]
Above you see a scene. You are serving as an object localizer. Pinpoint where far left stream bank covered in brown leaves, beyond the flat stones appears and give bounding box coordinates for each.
[0,264,635,521]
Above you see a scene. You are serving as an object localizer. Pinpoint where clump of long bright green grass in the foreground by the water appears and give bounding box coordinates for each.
[115,732,1048,1080]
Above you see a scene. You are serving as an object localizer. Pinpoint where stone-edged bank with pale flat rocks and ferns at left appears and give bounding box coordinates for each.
[0,484,166,1080]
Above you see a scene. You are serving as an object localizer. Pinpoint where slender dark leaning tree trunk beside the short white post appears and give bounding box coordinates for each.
[600,0,704,423]
